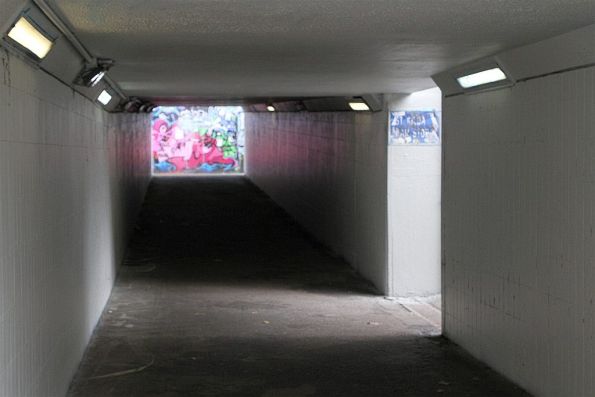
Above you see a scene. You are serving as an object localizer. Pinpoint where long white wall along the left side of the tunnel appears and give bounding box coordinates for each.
[0,53,150,397]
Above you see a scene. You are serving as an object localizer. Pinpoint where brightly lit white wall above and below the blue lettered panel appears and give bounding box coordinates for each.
[388,88,442,296]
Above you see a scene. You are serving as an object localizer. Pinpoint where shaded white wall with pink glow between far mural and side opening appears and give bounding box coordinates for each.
[246,111,388,293]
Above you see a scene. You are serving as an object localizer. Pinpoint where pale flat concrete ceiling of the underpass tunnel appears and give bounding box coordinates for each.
[50,0,595,100]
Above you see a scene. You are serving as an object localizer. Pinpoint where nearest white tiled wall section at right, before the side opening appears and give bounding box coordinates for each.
[443,67,595,397]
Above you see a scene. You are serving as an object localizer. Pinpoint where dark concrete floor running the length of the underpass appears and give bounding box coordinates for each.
[69,177,527,397]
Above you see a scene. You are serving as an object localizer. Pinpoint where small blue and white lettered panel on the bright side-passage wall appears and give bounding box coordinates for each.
[388,110,441,145]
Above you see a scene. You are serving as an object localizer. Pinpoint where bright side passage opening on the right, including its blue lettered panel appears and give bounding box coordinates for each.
[387,88,442,324]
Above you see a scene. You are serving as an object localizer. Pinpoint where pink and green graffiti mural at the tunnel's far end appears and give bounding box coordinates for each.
[151,106,244,174]
